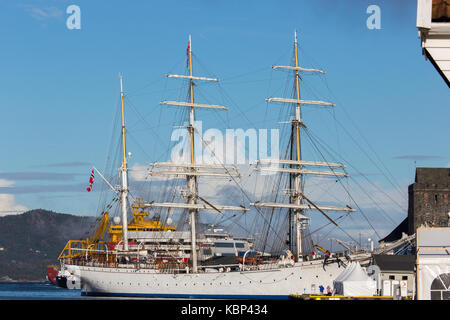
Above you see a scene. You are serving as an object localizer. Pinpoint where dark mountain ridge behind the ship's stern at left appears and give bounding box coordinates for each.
[0,209,95,281]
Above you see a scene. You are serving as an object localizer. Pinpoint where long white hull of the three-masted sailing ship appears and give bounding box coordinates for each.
[72,260,368,299]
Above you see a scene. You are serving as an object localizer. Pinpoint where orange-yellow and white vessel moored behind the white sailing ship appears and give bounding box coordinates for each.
[56,197,254,289]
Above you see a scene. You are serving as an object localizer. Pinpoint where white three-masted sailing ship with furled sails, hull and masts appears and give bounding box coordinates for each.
[59,34,367,299]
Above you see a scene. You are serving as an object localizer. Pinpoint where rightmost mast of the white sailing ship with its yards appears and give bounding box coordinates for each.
[251,31,355,261]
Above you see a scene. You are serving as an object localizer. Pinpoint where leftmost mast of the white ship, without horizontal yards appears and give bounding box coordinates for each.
[120,76,128,251]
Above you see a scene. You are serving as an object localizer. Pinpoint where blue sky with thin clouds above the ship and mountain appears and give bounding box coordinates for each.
[0,0,450,240]
